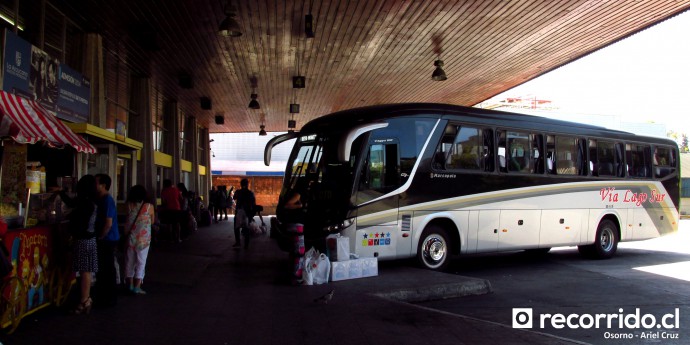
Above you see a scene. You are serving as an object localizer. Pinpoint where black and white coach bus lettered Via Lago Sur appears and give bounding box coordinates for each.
[264,104,680,270]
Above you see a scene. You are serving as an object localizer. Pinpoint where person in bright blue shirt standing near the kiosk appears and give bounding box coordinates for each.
[95,174,120,307]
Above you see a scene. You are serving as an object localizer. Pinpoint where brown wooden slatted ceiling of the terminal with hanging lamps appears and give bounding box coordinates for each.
[49,0,690,132]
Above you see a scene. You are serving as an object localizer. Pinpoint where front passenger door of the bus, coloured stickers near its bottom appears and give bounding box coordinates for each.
[355,138,400,258]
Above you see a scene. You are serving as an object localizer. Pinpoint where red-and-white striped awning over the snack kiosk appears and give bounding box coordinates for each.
[0,91,96,153]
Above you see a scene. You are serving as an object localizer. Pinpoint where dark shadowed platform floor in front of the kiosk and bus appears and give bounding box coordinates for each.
[0,218,578,345]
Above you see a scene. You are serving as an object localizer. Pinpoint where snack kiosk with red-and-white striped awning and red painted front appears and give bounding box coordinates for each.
[0,91,96,331]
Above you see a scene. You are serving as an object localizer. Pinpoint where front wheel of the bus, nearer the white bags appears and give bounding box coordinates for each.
[417,225,450,271]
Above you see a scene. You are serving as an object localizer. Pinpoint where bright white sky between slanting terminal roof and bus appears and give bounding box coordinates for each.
[486,12,690,135]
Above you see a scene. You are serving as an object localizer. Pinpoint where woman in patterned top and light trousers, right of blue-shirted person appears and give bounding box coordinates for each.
[125,185,155,295]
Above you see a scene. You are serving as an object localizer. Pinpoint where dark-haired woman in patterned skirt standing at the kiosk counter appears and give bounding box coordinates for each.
[59,175,98,314]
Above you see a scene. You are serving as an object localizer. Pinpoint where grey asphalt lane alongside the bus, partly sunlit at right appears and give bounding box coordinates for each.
[422,220,690,345]
